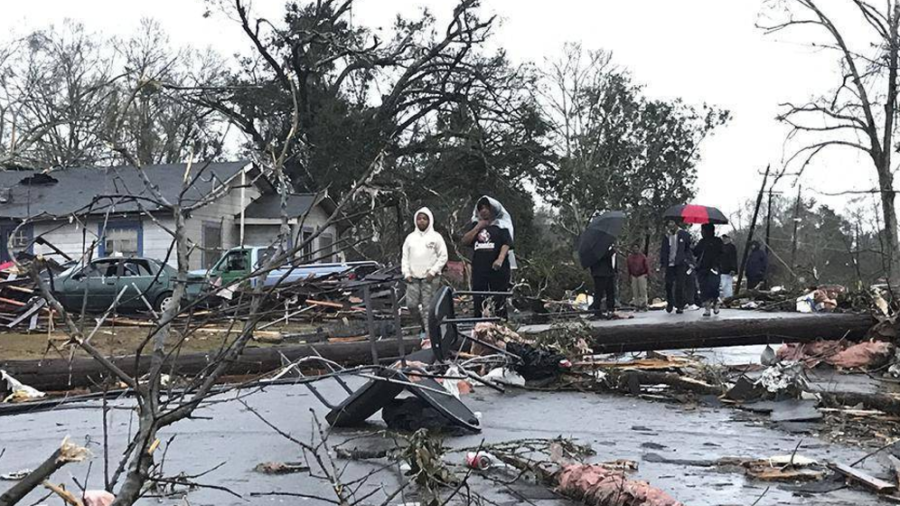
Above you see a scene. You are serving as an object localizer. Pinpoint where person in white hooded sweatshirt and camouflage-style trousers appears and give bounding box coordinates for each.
[401,207,447,334]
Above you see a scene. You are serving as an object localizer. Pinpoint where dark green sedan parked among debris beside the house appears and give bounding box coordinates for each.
[51,257,177,312]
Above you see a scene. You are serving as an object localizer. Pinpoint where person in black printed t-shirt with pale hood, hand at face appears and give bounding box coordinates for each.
[462,199,512,318]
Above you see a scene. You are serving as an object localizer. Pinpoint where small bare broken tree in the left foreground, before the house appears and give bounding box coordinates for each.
[2,57,380,506]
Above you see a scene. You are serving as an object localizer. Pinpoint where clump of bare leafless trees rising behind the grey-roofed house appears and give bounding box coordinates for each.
[0,20,232,169]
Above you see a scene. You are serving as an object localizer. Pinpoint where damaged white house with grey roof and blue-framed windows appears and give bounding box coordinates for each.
[0,161,340,269]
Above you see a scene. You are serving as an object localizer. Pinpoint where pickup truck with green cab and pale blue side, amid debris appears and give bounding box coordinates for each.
[188,246,380,298]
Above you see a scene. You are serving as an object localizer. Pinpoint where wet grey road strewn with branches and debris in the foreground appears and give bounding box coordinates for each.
[0,383,881,506]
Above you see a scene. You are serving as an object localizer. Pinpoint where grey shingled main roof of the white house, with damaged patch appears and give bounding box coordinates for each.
[0,160,250,219]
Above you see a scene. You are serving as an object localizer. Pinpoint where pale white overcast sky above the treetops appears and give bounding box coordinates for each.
[0,0,873,223]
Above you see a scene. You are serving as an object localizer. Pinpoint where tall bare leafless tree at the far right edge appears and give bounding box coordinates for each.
[759,0,900,277]
